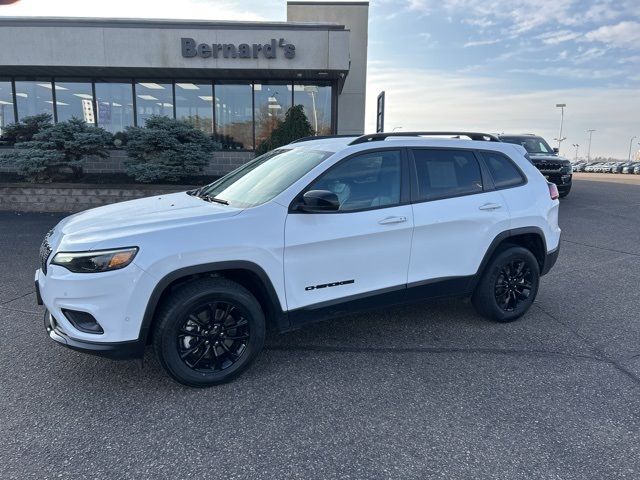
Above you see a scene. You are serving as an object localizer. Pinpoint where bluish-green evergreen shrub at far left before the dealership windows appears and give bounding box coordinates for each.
[3,117,112,183]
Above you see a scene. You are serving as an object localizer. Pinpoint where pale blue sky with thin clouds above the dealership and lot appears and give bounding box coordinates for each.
[0,0,640,158]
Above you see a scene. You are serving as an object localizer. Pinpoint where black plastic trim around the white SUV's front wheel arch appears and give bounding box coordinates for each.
[138,260,290,344]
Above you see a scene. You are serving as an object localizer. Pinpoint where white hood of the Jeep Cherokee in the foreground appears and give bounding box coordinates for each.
[55,192,242,248]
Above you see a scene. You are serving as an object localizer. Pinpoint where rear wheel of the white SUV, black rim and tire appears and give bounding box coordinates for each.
[471,246,540,322]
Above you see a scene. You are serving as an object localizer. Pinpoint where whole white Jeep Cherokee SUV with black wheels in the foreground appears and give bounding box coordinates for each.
[35,132,560,387]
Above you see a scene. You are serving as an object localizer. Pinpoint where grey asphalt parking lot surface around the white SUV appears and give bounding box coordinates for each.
[0,174,640,480]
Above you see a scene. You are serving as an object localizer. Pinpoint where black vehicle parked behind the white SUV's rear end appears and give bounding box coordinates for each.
[498,133,572,197]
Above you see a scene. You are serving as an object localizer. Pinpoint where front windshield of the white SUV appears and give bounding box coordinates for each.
[196,148,333,208]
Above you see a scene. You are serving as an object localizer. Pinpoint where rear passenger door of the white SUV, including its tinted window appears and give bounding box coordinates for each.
[408,148,510,286]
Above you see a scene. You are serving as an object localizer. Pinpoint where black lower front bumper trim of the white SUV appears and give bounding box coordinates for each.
[44,308,145,360]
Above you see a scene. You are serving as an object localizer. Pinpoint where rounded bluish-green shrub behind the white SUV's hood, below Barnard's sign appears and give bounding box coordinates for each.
[125,116,219,183]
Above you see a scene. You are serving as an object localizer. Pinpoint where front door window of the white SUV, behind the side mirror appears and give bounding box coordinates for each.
[307,150,401,211]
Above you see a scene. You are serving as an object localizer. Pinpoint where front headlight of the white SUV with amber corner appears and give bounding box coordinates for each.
[51,247,138,273]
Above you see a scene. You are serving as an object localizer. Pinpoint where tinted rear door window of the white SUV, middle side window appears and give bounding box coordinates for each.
[413,149,482,201]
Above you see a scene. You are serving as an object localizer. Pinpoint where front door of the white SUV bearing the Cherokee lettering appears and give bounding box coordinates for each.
[284,148,413,310]
